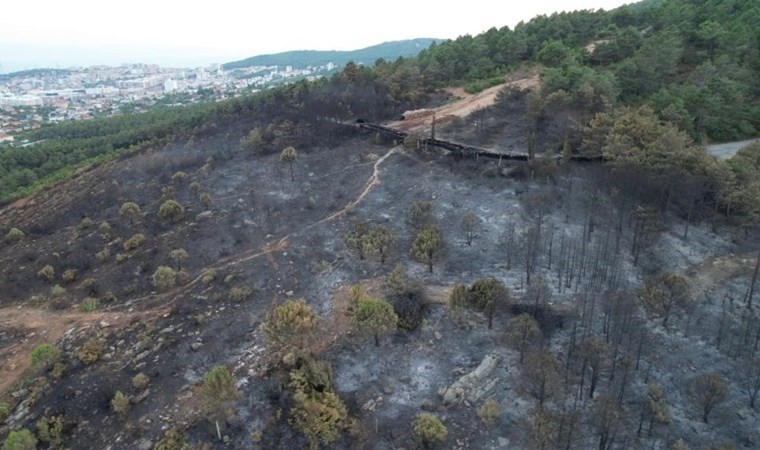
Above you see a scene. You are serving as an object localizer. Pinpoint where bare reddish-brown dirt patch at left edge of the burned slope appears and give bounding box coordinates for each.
[0,306,151,392]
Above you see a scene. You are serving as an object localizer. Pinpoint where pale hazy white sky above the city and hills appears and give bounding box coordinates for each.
[0,0,631,72]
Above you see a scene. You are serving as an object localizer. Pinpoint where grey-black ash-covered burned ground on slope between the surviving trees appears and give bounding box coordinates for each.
[0,125,760,449]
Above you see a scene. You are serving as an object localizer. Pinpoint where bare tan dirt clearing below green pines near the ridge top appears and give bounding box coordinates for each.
[388,69,541,131]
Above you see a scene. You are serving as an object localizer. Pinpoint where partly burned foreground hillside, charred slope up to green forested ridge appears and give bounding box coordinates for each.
[0,0,760,450]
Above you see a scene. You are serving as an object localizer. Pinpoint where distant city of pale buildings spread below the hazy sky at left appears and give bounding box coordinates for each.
[0,62,337,144]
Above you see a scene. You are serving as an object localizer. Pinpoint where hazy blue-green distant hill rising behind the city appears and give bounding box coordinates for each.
[223,38,443,70]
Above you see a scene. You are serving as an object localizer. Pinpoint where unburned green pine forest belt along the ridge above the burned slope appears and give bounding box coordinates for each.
[0,0,760,201]
